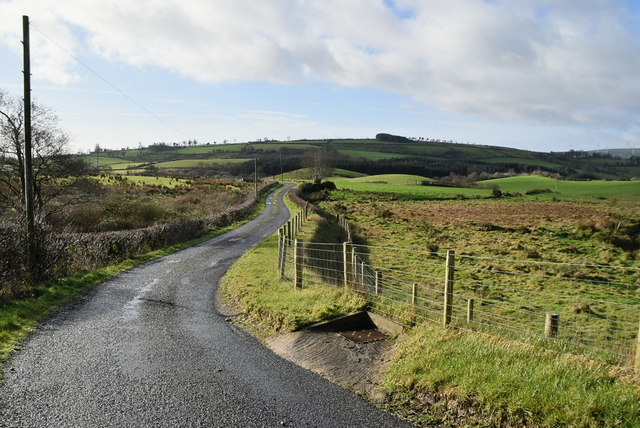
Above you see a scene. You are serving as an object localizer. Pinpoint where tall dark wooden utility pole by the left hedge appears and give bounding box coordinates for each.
[22,15,36,270]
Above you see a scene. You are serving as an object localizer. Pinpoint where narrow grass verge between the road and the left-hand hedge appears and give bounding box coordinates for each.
[0,185,278,380]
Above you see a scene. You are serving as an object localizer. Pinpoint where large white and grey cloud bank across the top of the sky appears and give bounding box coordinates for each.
[0,0,640,128]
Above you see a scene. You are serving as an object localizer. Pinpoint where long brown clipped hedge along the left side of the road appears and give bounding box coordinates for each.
[0,183,272,302]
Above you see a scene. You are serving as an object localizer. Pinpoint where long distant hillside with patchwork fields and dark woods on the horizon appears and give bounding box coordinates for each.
[87,138,640,179]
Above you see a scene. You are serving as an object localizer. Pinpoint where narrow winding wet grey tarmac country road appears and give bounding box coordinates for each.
[0,186,405,428]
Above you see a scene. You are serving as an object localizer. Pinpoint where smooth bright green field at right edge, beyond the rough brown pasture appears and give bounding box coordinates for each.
[478,175,640,201]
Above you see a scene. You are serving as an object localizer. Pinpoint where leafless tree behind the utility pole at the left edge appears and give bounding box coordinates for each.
[0,90,87,220]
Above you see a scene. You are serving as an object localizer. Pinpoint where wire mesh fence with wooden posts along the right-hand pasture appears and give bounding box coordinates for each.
[278,213,640,366]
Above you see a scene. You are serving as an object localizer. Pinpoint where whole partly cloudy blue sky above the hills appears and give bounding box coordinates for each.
[0,0,640,152]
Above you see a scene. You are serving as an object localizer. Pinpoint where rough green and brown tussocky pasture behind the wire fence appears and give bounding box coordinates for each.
[319,191,640,364]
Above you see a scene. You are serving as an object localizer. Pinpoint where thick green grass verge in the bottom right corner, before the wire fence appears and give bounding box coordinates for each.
[382,326,640,427]
